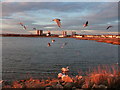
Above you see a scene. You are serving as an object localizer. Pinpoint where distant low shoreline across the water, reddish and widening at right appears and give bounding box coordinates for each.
[0,34,120,45]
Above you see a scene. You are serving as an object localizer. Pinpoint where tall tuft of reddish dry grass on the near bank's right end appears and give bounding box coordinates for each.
[86,65,120,87]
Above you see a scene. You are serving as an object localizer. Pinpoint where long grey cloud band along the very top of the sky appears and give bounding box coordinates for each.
[2,2,106,16]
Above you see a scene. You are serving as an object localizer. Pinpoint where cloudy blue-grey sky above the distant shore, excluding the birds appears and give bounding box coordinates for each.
[0,0,118,34]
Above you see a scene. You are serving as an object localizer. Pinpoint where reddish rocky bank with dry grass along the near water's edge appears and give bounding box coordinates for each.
[2,65,120,90]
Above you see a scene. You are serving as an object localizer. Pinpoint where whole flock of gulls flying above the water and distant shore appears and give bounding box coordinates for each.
[19,18,113,48]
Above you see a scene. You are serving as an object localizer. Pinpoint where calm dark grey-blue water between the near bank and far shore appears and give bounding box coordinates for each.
[2,37,118,80]
